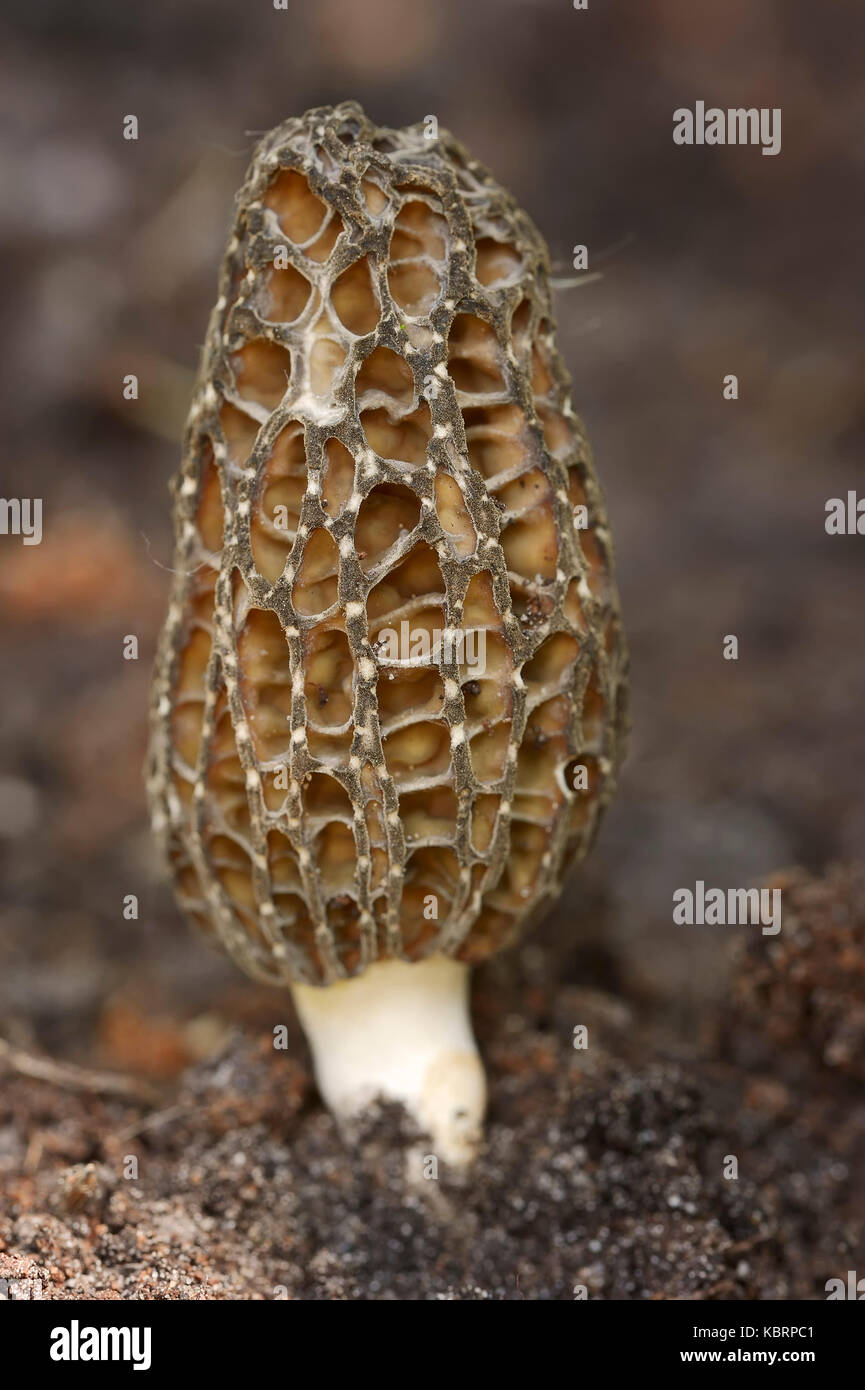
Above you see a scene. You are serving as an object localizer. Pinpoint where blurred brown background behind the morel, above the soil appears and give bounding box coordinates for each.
[0,0,865,1074]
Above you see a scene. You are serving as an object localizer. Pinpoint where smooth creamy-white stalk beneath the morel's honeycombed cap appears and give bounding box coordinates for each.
[292,956,487,1166]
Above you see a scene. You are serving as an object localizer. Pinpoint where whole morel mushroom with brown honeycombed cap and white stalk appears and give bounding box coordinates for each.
[149,103,626,1162]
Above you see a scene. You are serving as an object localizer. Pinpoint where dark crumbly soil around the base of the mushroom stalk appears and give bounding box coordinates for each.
[0,870,865,1300]
